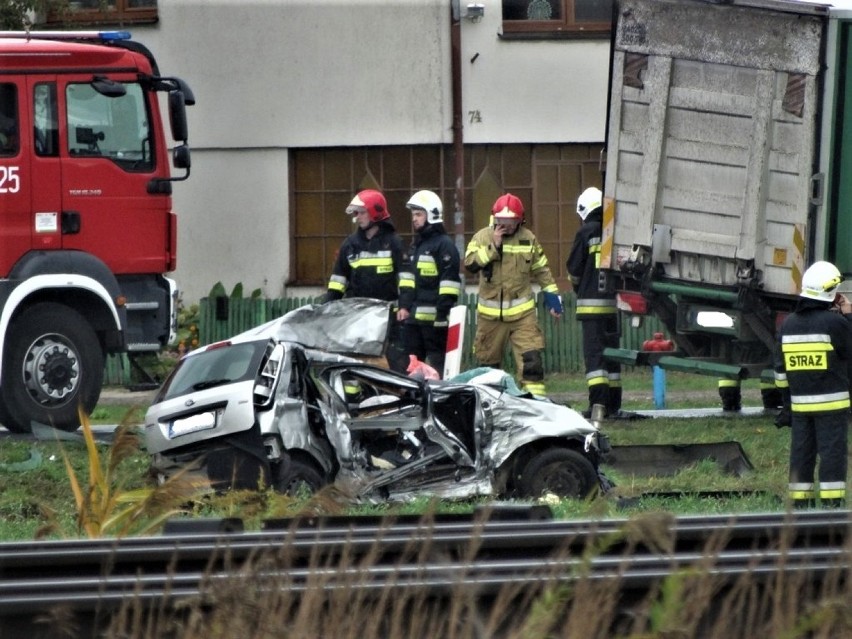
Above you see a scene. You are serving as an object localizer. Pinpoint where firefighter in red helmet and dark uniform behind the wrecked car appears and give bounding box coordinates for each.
[326,189,408,373]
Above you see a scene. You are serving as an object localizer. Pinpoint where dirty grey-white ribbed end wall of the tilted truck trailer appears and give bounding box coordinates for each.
[604,0,823,293]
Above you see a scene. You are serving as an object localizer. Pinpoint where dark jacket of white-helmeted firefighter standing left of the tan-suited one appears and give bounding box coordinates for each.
[399,223,461,326]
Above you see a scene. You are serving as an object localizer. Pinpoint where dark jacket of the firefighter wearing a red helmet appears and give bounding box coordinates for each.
[326,220,405,302]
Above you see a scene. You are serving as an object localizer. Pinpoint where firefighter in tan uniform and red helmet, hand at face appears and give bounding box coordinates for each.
[464,193,562,395]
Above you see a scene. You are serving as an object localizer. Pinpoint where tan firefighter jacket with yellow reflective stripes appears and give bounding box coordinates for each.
[464,226,559,322]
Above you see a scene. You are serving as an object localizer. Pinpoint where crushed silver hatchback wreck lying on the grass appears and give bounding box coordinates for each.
[145,299,609,502]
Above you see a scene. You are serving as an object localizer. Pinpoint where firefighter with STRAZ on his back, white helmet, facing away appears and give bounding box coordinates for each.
[775,262,852,508]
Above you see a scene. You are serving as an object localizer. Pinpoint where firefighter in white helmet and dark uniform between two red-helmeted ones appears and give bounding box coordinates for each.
[397,191,461,376]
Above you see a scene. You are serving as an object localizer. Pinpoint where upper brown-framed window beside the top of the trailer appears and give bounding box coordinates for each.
[502,0,612,37]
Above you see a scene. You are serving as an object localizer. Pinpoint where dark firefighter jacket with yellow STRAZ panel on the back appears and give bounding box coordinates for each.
[775,300,852,415]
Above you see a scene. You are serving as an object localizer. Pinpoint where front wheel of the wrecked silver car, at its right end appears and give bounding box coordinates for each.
[518,448,598,499]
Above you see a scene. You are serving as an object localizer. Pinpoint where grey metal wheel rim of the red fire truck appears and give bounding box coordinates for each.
[23,333,80,405]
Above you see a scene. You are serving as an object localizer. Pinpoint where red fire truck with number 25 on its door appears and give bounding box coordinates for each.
[0,31,195,432]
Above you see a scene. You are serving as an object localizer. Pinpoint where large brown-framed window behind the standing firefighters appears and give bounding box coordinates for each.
[288,144,602,290]
